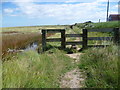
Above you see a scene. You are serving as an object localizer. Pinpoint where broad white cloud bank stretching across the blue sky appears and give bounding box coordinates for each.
[2,0,117,21]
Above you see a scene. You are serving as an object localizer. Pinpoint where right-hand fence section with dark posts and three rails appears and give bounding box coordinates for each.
[83,28,120,48]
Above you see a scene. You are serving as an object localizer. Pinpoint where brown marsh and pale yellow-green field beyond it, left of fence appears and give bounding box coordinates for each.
[0,25,66,56]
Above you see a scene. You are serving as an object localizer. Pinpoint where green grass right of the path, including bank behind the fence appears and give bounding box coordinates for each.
[74,21,120,88]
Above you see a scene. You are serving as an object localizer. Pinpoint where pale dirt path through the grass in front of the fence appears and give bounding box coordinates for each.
[60,53,85,88]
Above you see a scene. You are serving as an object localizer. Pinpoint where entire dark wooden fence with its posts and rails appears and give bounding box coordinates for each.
[42,28,120,52]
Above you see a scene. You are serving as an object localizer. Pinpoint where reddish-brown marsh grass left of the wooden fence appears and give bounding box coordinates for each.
[1,33,41,55]
